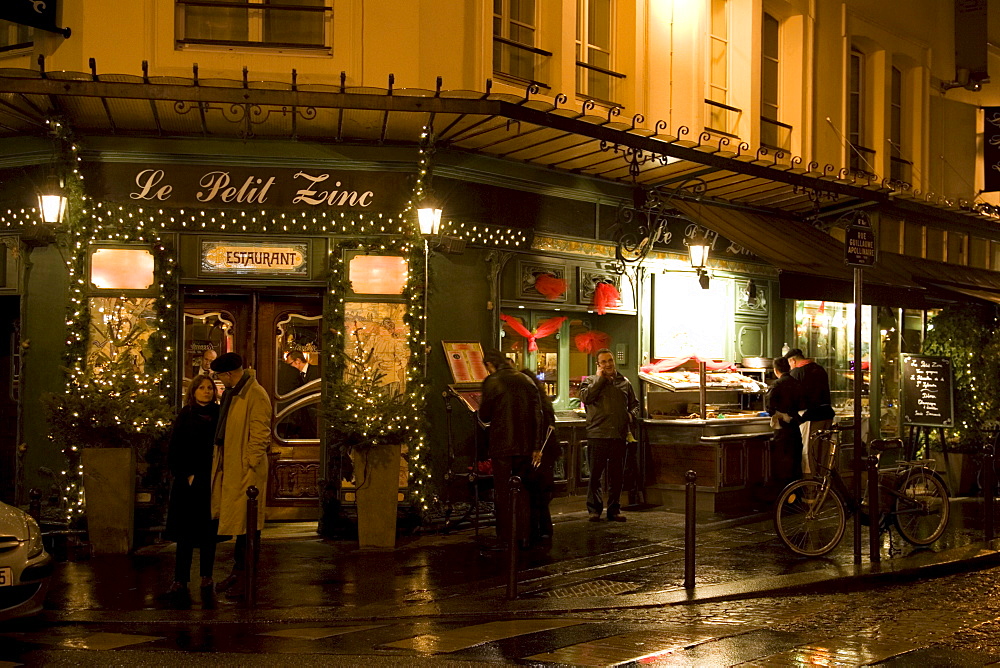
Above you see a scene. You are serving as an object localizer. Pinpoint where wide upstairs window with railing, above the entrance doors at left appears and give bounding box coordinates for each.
[176,0,331,49]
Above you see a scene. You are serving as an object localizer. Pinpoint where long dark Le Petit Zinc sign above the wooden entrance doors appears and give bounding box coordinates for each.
[95,163,413,211]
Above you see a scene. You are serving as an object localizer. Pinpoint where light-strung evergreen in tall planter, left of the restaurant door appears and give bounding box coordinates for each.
[42,324,174,554]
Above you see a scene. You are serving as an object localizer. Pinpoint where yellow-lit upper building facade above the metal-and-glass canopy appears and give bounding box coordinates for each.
[0,0,1000,267]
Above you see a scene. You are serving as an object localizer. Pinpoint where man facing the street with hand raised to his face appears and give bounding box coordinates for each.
[580,348,639,522]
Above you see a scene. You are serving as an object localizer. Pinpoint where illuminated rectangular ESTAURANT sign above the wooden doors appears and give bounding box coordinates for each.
[201,240,309,278]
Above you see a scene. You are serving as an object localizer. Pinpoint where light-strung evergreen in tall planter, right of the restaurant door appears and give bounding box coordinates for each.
[326,334,412,547]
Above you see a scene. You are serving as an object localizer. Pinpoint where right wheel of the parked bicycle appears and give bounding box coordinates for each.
[893,467,951,545]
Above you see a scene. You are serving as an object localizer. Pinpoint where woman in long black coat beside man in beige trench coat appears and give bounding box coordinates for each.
[165,375,219,594]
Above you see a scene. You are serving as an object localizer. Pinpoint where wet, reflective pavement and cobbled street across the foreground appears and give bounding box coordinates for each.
[0,500,1000,667]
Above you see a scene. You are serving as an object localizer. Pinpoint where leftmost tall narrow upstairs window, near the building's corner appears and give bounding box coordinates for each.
[493,0,552,87]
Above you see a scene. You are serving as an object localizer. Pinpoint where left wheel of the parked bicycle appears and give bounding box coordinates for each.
[774,480,847,557]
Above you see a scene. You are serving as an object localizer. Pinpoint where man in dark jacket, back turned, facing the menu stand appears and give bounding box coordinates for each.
[479,350,540,545]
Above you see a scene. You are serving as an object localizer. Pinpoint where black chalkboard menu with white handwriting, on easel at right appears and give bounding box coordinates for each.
[903,355,954,427]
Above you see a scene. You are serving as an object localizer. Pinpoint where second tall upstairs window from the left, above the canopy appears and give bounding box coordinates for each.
[576,0,625,101]
